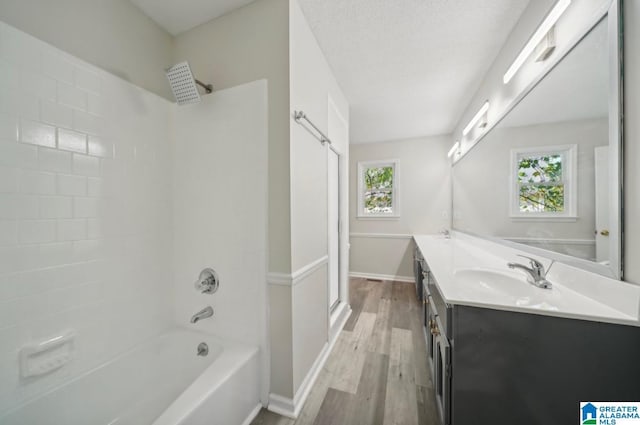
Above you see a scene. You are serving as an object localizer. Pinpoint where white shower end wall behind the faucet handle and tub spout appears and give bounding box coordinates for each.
[172,80,268,398]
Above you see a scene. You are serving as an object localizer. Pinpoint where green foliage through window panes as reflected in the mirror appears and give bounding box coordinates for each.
[518,154,565,213]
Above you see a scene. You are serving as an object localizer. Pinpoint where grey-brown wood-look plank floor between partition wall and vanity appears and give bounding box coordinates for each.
[252,279,438,425]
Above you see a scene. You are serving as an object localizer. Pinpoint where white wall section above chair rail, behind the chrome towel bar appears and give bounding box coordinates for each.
[289,1,349,270]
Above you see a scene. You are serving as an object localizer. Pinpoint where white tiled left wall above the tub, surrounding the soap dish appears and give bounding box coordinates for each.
[0,23,173,414]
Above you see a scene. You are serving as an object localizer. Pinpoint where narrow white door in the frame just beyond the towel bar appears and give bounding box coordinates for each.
[327,149,340,309]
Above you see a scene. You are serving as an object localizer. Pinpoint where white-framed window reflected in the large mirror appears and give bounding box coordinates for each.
[510,145,577,220]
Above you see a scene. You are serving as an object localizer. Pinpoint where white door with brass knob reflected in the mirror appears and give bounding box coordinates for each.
[595,146,610,264]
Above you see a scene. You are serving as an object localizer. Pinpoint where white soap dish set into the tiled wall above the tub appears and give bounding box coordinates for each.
[20,330,76,378]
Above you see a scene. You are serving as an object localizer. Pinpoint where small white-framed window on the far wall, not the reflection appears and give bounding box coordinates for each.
[358,160,400,218]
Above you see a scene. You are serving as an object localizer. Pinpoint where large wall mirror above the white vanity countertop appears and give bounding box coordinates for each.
[453,11,621,278]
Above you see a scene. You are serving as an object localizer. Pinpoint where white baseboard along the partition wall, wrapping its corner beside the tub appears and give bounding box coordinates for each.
[267,304,351,419]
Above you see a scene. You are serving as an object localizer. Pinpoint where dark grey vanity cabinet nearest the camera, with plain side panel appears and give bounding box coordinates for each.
[422,255,640,425]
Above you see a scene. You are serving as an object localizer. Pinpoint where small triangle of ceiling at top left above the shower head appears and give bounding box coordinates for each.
[131,0,253,35]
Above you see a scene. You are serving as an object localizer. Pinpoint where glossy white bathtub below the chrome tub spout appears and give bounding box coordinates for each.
[0,328,261,425]
